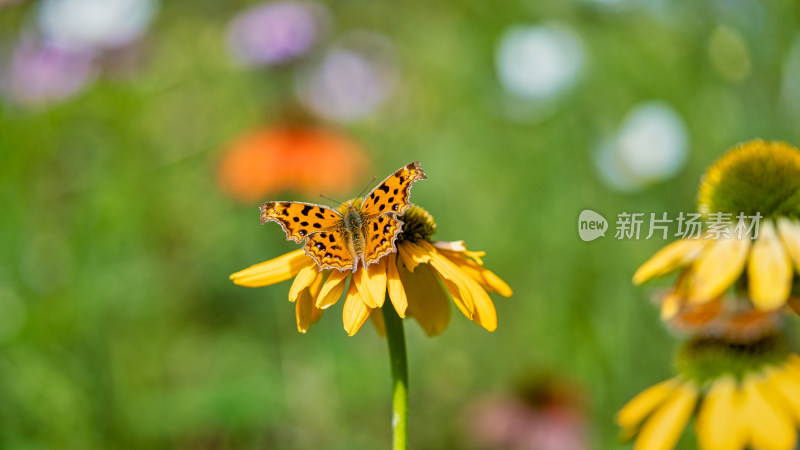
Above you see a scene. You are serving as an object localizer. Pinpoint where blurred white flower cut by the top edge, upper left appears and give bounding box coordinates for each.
[39,0,158,50]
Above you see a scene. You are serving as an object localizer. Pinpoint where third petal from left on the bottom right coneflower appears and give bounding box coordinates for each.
[695,376,746,450]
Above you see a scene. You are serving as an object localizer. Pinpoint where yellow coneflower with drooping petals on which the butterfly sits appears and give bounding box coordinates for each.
[230,206,512,336]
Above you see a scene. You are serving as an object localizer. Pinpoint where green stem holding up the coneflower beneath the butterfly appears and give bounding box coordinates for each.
[381,298,408,450]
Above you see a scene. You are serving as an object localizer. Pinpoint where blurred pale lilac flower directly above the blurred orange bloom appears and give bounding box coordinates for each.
[295,32,397,122]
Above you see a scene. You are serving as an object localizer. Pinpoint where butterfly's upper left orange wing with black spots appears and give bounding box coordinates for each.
[261,202,342,244]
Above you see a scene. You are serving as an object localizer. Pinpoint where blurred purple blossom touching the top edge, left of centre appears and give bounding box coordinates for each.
[228,1,326,66]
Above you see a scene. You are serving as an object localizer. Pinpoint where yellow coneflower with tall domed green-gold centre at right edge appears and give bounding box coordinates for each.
[633,140,800,311]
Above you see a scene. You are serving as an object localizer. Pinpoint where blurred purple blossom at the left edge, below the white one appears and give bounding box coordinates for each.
[0,39,93,106]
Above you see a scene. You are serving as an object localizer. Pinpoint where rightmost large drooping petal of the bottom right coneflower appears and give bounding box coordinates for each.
[742,375,797,450]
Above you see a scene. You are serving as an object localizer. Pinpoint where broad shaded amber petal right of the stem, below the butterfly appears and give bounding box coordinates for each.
[397,264,450,336]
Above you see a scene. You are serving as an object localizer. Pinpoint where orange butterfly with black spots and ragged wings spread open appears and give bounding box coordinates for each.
[260,161,427,272]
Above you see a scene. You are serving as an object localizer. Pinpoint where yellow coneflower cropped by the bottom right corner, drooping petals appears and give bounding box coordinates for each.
[616,335,800,450]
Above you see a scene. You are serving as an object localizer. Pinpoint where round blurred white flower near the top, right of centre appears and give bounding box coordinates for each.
[496,23,584,100]
